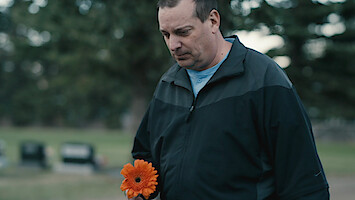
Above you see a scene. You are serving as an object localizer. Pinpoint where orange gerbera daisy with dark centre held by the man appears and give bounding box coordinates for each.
[121,160,158,199]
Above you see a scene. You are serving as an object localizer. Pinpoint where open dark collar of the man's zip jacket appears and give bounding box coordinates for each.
[162,35,247,90]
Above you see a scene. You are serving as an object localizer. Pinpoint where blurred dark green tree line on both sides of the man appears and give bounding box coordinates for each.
[0,0,355,129]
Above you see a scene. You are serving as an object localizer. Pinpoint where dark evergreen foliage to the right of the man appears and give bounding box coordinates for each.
[232,0,355,119]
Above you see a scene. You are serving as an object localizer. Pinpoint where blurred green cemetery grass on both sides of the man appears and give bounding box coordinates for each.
[0,127,355,200]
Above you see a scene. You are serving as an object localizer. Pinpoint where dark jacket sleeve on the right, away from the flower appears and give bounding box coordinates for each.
[264,85,329,200]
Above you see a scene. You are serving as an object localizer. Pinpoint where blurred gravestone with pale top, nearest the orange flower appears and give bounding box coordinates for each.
[56,142,97,174]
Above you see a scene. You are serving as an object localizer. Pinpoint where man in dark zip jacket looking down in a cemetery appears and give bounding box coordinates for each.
[132,0,329,200]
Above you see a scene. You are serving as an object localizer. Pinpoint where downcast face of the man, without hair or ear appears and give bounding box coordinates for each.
[158,0,217,70]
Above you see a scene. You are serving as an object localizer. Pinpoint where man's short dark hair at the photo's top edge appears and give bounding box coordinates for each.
[157,0,218,22]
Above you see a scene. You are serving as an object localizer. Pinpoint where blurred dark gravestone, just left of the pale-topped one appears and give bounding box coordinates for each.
[20,141,48,168]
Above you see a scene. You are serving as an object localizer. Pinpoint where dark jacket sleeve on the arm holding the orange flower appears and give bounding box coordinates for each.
[132,102,159,199]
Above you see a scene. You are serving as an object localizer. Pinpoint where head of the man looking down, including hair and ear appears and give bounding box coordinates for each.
[158,0,223,70]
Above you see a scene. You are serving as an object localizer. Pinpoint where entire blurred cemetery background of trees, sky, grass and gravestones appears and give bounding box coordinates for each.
[0,0,355,200]
